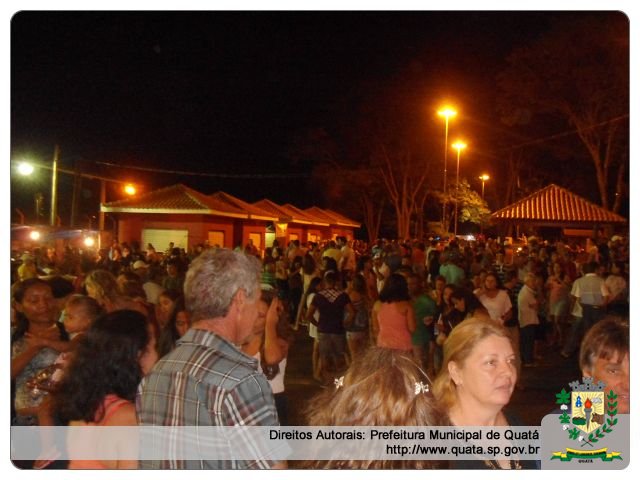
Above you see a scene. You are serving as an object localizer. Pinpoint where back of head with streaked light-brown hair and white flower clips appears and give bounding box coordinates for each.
[305,347,443,469]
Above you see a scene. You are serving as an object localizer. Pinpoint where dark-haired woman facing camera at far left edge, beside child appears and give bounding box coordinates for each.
[11,278,70,425]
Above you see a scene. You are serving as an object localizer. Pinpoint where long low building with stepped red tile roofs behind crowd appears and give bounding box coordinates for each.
[100,184,360,251]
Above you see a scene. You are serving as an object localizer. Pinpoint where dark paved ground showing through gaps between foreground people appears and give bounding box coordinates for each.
[285,327,580,425]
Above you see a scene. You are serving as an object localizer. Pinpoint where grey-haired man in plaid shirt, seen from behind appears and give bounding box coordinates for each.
[136,249,285,469]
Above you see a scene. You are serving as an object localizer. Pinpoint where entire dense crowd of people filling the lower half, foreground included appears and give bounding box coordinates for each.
[11,232,629,468]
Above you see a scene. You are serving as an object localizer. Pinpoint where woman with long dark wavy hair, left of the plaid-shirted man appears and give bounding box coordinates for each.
[52,310,158,469]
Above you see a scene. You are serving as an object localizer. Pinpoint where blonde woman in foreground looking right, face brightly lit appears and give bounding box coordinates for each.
[433,317,536,469]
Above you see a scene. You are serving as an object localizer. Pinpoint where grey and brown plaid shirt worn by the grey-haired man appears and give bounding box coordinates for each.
[136,329,279,469]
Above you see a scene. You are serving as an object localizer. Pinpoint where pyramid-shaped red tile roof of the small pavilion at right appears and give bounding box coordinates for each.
[491,184,627,224]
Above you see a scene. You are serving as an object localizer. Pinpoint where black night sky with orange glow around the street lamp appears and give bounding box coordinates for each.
[11,12,624,228]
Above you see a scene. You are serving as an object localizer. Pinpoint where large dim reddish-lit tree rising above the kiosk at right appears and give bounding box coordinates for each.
[498,13,629,211]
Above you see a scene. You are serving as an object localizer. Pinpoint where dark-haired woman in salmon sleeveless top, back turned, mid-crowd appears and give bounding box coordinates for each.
[371,273,416,352]
